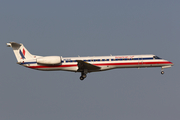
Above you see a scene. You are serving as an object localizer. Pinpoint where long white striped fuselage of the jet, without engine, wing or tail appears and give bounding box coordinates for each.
[20,55,173,72]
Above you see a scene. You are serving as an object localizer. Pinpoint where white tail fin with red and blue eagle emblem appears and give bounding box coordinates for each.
[7,42,33,62]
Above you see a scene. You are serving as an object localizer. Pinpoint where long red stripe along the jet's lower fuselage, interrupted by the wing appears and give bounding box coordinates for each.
[28,61,173,69]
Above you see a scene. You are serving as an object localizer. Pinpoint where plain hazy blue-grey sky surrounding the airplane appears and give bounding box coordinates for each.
[0,0,180,120]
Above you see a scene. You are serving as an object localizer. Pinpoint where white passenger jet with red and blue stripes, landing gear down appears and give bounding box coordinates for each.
[7,42,174,80]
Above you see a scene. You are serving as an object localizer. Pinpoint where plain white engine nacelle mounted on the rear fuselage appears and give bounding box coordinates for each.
[37,56,61,65]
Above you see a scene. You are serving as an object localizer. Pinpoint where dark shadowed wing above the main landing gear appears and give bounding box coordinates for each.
[76,60,100,72]
